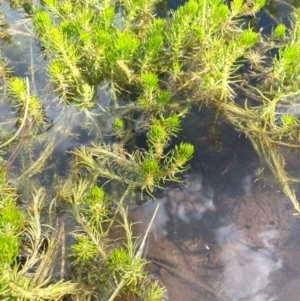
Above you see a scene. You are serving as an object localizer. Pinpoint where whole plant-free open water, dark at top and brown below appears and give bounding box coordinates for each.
[131,109,300,301]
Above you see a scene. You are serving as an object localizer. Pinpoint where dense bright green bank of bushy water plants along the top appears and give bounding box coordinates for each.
[29,0,264,111]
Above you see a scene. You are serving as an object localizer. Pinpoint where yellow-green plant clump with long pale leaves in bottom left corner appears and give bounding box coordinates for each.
[0,190,79,300]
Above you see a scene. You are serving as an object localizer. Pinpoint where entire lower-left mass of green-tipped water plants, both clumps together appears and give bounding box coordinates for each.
[0,176,165,301]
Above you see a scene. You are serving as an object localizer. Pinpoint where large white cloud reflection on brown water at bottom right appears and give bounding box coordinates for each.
[216,224,282,301]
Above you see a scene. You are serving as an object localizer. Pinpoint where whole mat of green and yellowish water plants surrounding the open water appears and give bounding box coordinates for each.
[0,0,300,300]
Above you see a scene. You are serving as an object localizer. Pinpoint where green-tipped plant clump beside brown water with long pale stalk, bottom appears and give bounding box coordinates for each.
[63,182,165,300]
